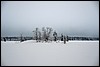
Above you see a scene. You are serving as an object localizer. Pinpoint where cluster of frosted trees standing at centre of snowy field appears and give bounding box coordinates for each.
[33,27,68,42]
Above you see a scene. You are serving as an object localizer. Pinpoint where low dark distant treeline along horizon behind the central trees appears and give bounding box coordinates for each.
[1,37,99,41]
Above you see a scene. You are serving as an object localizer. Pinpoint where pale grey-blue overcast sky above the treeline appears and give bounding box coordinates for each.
[1,1,99,37]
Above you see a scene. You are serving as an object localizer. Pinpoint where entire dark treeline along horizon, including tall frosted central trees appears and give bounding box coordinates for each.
[1,27,99,42]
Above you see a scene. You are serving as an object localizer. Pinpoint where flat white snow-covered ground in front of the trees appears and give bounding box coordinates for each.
[1,40,99,66]
